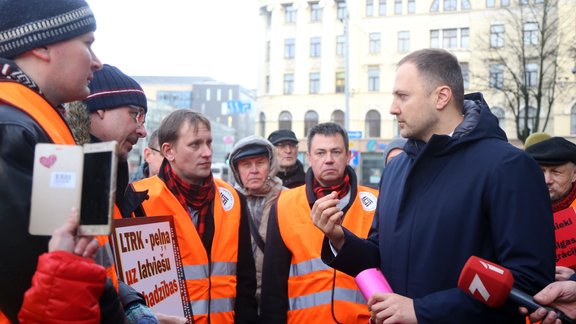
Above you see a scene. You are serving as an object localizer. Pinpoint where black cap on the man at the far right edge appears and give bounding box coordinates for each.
[526,137,576,165]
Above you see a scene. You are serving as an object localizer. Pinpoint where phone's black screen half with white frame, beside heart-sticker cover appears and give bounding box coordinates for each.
[78,141,117,235]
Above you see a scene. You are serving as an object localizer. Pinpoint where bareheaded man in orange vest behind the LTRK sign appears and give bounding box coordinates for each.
[126,109,257,324]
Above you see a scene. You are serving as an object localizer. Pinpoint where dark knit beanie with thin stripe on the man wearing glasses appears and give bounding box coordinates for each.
[84,64,148,112]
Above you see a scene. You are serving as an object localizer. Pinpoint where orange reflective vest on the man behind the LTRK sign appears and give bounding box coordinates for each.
[132,176,241,323]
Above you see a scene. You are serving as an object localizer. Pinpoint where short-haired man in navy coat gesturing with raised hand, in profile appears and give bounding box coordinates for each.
[311,49,555,323]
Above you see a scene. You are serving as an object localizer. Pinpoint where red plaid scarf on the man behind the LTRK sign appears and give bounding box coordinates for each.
[161,161,216,237]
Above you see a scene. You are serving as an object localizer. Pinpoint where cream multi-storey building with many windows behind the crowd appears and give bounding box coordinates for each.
[256,0,576,185]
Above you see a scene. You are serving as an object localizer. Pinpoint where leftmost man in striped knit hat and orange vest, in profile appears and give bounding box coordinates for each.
[0,0,102,322]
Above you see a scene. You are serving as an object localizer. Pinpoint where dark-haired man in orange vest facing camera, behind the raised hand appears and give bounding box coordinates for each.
[261,123,378,323]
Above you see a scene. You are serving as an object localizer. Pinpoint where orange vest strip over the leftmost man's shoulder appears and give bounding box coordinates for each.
[0,82,76,145]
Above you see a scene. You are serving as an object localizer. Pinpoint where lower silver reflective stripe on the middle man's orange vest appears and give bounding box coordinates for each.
[288,287,366,310]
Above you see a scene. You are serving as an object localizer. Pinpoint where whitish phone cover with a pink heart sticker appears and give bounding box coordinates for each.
[28,143,84,235]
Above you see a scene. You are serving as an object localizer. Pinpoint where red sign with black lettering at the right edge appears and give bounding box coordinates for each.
[554,207,576,268]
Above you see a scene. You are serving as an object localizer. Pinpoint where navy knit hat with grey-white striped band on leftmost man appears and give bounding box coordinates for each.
[0,0,96,58]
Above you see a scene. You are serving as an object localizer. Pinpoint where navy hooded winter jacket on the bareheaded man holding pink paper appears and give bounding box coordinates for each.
[322,93,555,323]
